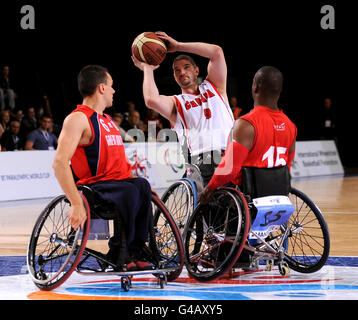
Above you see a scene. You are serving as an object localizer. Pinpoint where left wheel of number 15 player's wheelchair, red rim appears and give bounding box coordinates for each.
[183,188,250,281]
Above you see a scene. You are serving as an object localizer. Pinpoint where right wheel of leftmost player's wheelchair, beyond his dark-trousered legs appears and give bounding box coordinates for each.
[152,195,184,281]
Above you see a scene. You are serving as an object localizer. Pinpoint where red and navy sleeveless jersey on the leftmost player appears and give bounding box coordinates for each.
[71,105,131,185]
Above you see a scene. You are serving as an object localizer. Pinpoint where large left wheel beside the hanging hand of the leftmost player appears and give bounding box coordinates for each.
[27,194,90,290]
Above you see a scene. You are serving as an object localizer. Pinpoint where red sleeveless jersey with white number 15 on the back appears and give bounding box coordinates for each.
[234,106,297,185]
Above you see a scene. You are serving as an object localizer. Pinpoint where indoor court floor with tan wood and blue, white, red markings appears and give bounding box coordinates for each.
[0,175,358,300]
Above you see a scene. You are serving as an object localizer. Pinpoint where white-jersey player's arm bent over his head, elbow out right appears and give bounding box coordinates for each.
[156,32,228,100]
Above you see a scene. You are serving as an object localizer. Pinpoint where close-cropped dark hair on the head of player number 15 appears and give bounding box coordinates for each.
[255,66,283,98]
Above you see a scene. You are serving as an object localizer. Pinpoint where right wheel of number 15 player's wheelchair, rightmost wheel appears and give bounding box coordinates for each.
[281,188,330,273]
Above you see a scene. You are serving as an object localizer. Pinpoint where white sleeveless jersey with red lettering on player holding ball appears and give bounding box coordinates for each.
[172,80,234,156]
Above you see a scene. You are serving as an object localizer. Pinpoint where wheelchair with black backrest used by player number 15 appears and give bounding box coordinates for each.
[183,166,330,282]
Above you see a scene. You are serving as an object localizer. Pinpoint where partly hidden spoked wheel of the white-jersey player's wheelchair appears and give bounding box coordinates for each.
[162,180,195,233]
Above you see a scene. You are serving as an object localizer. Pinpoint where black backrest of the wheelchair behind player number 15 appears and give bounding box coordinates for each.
[240,166,291,199]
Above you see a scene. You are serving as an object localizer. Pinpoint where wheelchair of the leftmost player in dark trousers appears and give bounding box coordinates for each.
[27,186,184,291]
